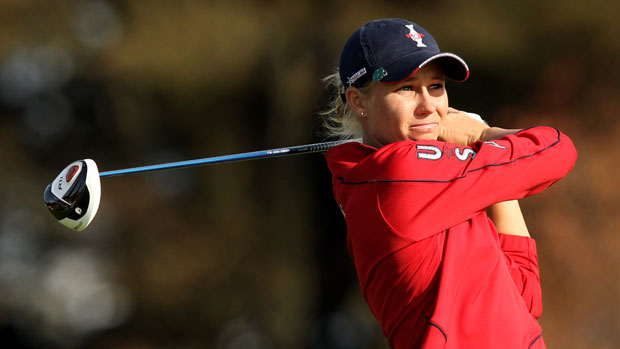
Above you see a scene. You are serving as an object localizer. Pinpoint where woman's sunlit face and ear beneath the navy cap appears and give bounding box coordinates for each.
[360,62,448,148]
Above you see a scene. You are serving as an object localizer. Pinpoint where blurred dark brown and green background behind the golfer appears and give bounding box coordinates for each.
[0,0,620,349]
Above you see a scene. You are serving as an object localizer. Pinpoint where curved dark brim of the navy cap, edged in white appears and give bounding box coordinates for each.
[381,51,469,82]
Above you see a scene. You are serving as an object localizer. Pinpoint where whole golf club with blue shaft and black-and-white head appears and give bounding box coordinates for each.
[43,139,361,231]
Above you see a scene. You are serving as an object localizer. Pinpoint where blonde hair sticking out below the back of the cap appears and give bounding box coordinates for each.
[319,69,372,140]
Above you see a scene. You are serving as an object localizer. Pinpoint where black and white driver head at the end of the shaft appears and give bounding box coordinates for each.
[43,159,101,231]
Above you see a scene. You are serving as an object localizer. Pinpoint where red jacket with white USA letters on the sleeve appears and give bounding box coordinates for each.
[326,127,577,348]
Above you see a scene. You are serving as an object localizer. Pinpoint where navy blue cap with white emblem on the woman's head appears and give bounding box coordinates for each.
[339,18,469,91]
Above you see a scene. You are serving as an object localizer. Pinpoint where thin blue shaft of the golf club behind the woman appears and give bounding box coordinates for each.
[99,139,362,178]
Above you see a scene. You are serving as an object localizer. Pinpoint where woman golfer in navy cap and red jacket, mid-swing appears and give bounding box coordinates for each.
[325,19,577,348]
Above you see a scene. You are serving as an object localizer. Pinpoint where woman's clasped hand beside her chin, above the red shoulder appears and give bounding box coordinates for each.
[438,108,489,146]
